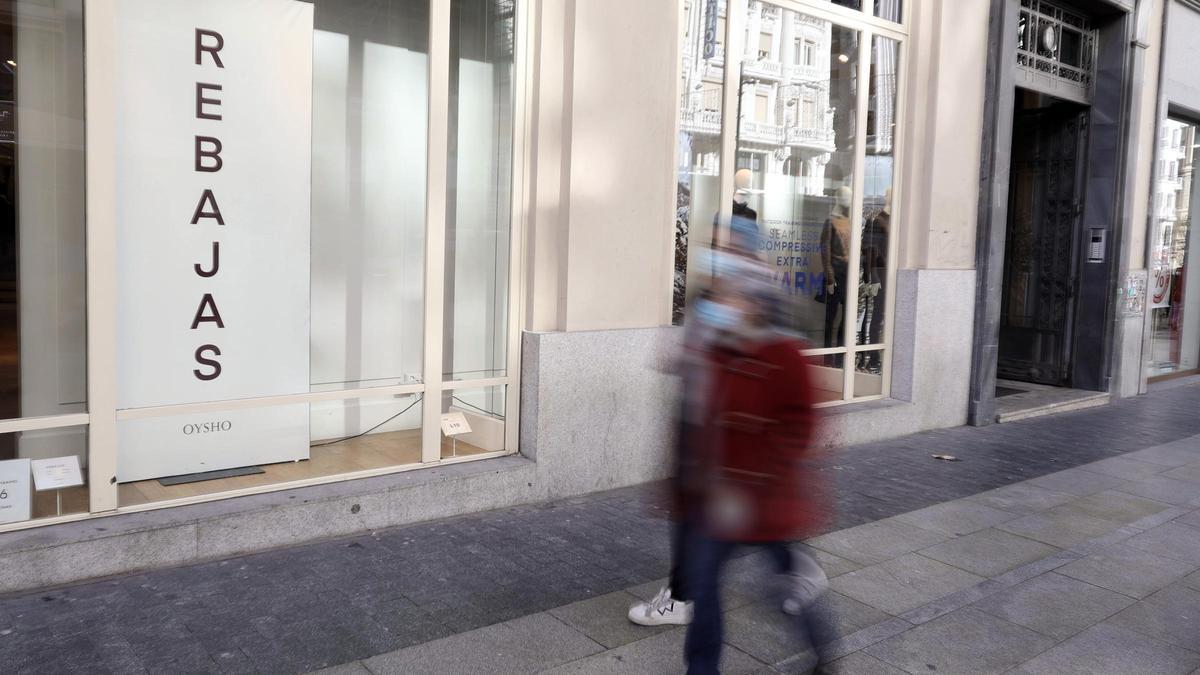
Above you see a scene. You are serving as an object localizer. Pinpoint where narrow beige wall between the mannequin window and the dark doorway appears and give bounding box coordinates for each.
[900,0,990,269]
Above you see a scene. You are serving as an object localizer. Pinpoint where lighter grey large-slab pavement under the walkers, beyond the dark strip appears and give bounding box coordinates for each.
[326,436,1200,675]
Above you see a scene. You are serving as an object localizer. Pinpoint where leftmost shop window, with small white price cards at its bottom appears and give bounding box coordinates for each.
[0,0,90,527]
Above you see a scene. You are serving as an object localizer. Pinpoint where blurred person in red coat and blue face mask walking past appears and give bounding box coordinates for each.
[677,228,832,675]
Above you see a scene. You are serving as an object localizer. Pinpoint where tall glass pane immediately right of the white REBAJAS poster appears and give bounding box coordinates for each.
[310,0,436,390]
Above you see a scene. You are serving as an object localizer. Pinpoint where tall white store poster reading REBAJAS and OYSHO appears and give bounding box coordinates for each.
[114,0,313,482]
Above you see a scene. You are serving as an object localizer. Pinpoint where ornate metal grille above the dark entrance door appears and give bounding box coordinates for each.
[1016,0,1097,103]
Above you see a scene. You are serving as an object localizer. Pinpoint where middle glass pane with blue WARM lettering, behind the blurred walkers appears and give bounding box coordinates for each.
[733,10,859,353]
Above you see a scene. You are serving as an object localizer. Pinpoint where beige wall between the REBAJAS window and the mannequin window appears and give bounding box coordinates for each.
[526,0,678,330]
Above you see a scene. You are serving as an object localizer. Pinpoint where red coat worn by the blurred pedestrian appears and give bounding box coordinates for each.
[679,336,828,542]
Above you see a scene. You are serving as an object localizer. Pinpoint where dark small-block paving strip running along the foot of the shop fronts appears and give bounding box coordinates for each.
[7,380,1200,673]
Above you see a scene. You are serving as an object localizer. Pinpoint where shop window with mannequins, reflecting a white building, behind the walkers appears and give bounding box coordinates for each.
[680,1,901,404]
